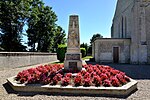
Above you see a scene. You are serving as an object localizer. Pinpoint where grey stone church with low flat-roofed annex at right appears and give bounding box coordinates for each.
[92,0,150,64]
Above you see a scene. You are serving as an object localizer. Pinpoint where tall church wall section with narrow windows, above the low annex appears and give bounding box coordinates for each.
[111,0,134,38]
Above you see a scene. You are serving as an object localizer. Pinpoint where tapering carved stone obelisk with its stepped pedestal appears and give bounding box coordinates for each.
[64,15,82,72]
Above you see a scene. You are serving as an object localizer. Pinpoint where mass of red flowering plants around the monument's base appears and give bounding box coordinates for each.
[15,64,130,87]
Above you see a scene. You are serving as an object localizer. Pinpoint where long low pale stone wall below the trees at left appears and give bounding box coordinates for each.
[0,52,57,68]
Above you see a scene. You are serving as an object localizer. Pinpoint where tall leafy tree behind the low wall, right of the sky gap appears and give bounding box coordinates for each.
[27,3,57,52]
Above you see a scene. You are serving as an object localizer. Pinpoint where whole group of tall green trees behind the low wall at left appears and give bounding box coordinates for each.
[0,0,65,52]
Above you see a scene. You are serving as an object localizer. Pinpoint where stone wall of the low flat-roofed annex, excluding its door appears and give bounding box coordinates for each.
[92,38,130,63]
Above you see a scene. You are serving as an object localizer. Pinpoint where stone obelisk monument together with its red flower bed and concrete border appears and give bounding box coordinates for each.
[7,15,137,96]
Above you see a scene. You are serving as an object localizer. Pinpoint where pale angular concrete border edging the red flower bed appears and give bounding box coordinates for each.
[7,77,137,97]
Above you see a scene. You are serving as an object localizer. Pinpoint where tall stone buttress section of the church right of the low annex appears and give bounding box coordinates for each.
[131,0,150,64]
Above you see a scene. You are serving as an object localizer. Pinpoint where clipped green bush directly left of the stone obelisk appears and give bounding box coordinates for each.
[57,44,67,62]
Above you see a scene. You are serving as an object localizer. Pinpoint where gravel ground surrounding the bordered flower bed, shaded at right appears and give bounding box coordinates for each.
[0,65,150,100]
